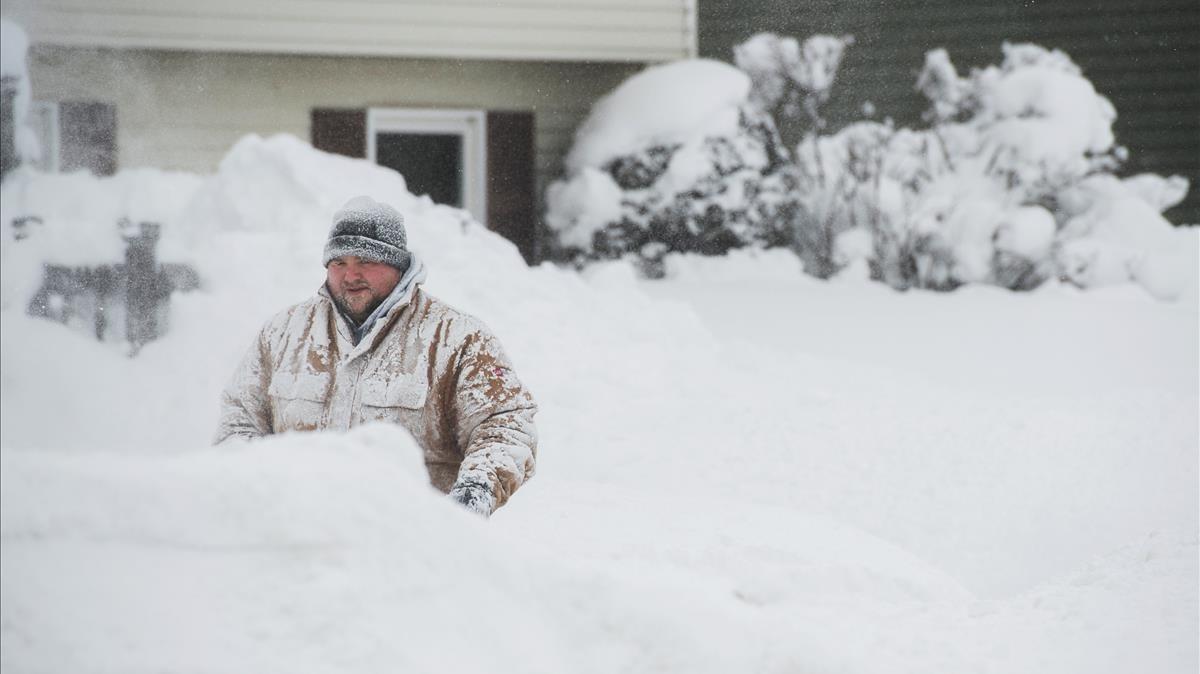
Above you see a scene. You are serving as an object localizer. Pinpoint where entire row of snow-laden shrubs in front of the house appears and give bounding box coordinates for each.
[546,34,1193,297]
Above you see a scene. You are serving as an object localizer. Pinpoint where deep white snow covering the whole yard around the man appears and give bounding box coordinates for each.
[0,133,1200,674]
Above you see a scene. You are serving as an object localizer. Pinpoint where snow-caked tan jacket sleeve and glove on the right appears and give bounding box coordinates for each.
[451,325,538,514]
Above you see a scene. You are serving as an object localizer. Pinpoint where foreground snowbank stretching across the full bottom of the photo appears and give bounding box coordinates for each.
[7,419,1196,673]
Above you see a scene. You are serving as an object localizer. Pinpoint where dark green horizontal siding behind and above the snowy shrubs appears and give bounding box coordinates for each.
[698,0,1200,223]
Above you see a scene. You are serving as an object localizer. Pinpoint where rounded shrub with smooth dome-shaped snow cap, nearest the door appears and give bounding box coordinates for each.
[546,60,793,261]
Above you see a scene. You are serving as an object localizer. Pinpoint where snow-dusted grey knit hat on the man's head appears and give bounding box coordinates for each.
[323,197,413,271]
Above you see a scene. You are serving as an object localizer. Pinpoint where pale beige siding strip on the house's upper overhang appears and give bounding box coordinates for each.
[2,0,696,62]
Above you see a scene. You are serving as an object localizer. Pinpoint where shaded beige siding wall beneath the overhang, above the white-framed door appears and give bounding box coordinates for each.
[30,47,641,193]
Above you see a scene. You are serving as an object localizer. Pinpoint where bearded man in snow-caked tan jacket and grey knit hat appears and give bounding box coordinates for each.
[215,197,538,516]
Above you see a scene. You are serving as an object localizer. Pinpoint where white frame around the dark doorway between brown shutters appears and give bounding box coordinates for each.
[367,108,487,227]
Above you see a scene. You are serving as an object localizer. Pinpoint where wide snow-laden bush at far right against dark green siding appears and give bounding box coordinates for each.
[794,44,1187,294]
